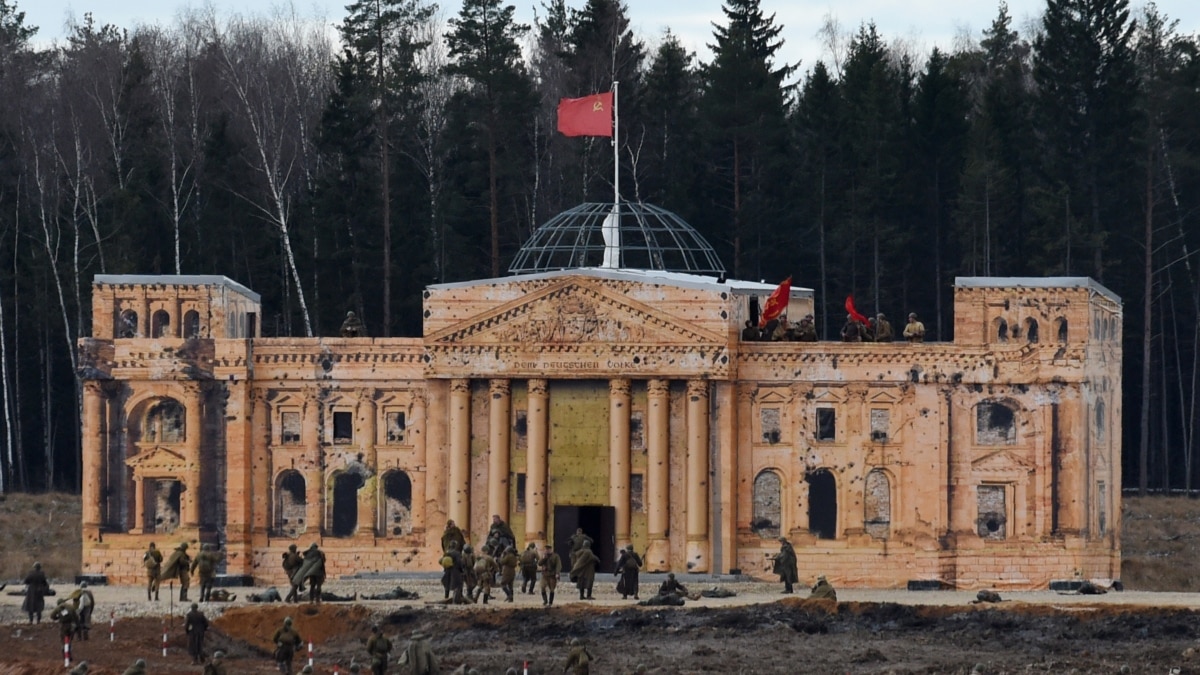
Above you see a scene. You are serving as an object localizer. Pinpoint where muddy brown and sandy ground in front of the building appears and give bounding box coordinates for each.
[0,575,1200,675]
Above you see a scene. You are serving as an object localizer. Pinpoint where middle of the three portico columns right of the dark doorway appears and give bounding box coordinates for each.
[646,380,671,572]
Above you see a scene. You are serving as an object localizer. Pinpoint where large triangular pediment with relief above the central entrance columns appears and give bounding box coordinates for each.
[428,279,725,346]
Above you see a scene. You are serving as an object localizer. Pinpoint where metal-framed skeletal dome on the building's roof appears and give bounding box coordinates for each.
[509,202,725,276]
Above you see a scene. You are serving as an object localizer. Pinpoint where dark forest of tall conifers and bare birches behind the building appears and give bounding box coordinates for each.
[0,0,1200,491]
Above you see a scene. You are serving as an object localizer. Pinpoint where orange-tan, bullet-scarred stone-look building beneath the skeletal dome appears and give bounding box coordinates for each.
[80,269,1121,589]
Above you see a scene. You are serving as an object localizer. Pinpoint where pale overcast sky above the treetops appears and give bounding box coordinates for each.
[16,0,1200,70]
